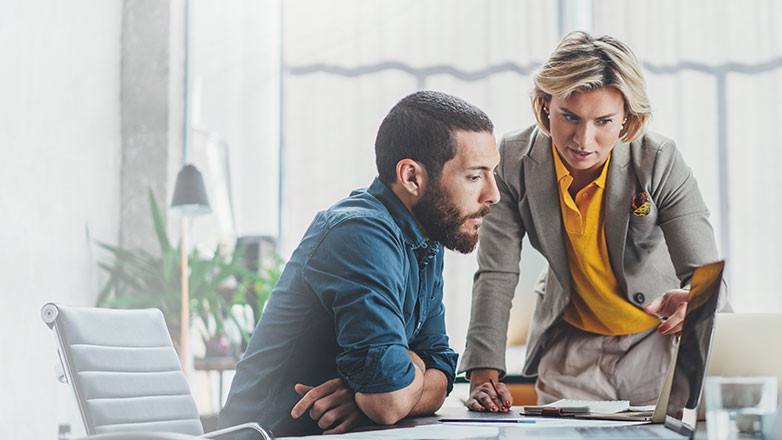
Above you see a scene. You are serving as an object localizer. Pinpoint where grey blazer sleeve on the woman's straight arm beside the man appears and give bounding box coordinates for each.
[459,134,526,377]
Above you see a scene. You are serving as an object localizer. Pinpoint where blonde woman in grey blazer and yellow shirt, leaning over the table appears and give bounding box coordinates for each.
[460,32,718,411]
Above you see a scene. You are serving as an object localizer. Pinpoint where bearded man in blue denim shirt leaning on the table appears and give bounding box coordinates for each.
[219,91,499,436]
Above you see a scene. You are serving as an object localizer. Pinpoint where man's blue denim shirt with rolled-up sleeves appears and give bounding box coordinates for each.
[219,178,457,436]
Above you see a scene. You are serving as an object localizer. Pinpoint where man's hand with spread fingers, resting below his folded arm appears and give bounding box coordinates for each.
[291,378,363,434]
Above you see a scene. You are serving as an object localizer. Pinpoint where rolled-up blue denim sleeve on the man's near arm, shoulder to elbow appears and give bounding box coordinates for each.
[302,217,415,393]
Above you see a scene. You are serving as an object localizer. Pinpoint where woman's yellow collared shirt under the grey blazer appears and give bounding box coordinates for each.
[552,143,660,335]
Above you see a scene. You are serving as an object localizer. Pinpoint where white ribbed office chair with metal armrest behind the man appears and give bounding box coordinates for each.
[41,303,274,440]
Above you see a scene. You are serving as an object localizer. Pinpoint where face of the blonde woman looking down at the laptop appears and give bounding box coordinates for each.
[546,87,625,178]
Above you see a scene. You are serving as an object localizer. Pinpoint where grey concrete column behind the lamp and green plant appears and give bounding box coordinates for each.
[119,0,184,252]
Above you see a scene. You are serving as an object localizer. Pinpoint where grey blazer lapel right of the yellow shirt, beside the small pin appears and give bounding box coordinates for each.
[603,141,636,286]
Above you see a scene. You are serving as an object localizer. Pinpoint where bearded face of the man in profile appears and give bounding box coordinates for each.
[413,130,500,254]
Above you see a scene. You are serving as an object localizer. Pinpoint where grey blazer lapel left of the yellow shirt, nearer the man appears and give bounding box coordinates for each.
[524,132,570,295]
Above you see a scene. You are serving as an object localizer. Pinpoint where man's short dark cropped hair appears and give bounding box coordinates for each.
[375,90,494,186]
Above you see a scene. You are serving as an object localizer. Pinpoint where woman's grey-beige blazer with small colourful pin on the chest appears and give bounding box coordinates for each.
[459,126,718,376]
